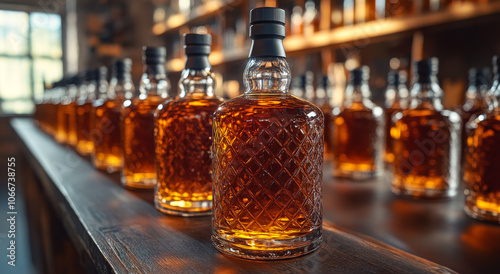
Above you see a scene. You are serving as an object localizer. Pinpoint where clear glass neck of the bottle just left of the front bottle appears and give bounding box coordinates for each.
[179,66,215,98]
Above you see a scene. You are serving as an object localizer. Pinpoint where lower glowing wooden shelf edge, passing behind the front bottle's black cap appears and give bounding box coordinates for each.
[167,3,500,72]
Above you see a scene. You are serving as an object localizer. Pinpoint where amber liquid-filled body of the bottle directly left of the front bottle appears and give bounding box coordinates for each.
[155,98,221,216]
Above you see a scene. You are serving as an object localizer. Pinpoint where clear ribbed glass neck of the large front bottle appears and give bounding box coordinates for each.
[243,57,291,95]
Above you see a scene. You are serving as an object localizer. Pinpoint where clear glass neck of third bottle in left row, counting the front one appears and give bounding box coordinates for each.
[139,63,170,98]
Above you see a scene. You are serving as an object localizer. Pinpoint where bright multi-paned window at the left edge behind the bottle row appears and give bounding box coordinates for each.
[0,10,63,113]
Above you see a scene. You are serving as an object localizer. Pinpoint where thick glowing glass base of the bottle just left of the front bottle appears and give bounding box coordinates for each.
[155,197,212,217]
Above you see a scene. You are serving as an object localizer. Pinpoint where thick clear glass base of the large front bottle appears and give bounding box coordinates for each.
[212,228,323,260]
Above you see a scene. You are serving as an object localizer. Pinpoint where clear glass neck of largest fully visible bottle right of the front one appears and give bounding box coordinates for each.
[410,75,443,110]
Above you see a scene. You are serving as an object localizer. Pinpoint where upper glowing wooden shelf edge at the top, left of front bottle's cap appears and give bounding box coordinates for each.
[153,0,236,35]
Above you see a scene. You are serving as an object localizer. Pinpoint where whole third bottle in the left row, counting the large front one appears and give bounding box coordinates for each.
[121,47,170,189]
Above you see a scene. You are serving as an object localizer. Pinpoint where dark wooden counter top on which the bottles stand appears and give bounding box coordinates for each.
[12,118,500,273]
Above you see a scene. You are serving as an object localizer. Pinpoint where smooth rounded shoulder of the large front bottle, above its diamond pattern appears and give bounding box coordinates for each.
[214,94,323,119]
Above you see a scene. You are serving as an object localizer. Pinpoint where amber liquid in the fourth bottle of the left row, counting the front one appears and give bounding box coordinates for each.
[92,99,125,173]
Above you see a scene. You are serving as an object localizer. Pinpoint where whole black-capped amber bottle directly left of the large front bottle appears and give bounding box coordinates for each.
[155,33,221,216]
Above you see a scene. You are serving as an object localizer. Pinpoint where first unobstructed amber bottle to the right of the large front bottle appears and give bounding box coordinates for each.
[333,66,384,180]
